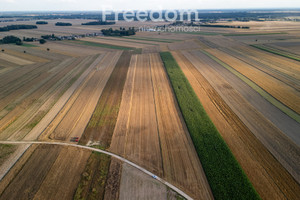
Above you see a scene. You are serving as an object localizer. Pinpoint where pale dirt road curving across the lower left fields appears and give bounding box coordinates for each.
[0,141,192,200]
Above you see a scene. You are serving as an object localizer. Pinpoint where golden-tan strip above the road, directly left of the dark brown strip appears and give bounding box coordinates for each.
[40,51,121,140]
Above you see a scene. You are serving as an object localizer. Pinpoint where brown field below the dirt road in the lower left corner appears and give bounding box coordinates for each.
[0,145,90,199]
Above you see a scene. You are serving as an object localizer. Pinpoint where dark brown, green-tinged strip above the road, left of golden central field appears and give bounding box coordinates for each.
[80,51,131,148]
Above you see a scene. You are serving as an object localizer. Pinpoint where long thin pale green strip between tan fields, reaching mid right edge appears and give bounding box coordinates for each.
[202,50,300,123]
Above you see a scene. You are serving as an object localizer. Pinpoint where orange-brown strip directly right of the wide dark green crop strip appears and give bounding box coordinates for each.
[172,52,300,199]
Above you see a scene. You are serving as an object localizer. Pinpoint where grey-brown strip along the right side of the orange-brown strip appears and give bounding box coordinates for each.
[183,51,300,182]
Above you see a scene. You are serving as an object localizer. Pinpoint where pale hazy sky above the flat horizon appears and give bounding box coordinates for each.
[0,0,300,11]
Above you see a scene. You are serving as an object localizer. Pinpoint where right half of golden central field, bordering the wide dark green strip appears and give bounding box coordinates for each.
[150,54,213,199]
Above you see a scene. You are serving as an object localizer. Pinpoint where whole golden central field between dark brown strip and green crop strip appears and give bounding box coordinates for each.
[109,54,212,198]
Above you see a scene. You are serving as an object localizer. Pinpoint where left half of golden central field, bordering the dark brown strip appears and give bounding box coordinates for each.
[109,55,162,175]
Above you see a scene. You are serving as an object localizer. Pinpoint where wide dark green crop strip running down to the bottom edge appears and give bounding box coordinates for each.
[160,52,260,200]
